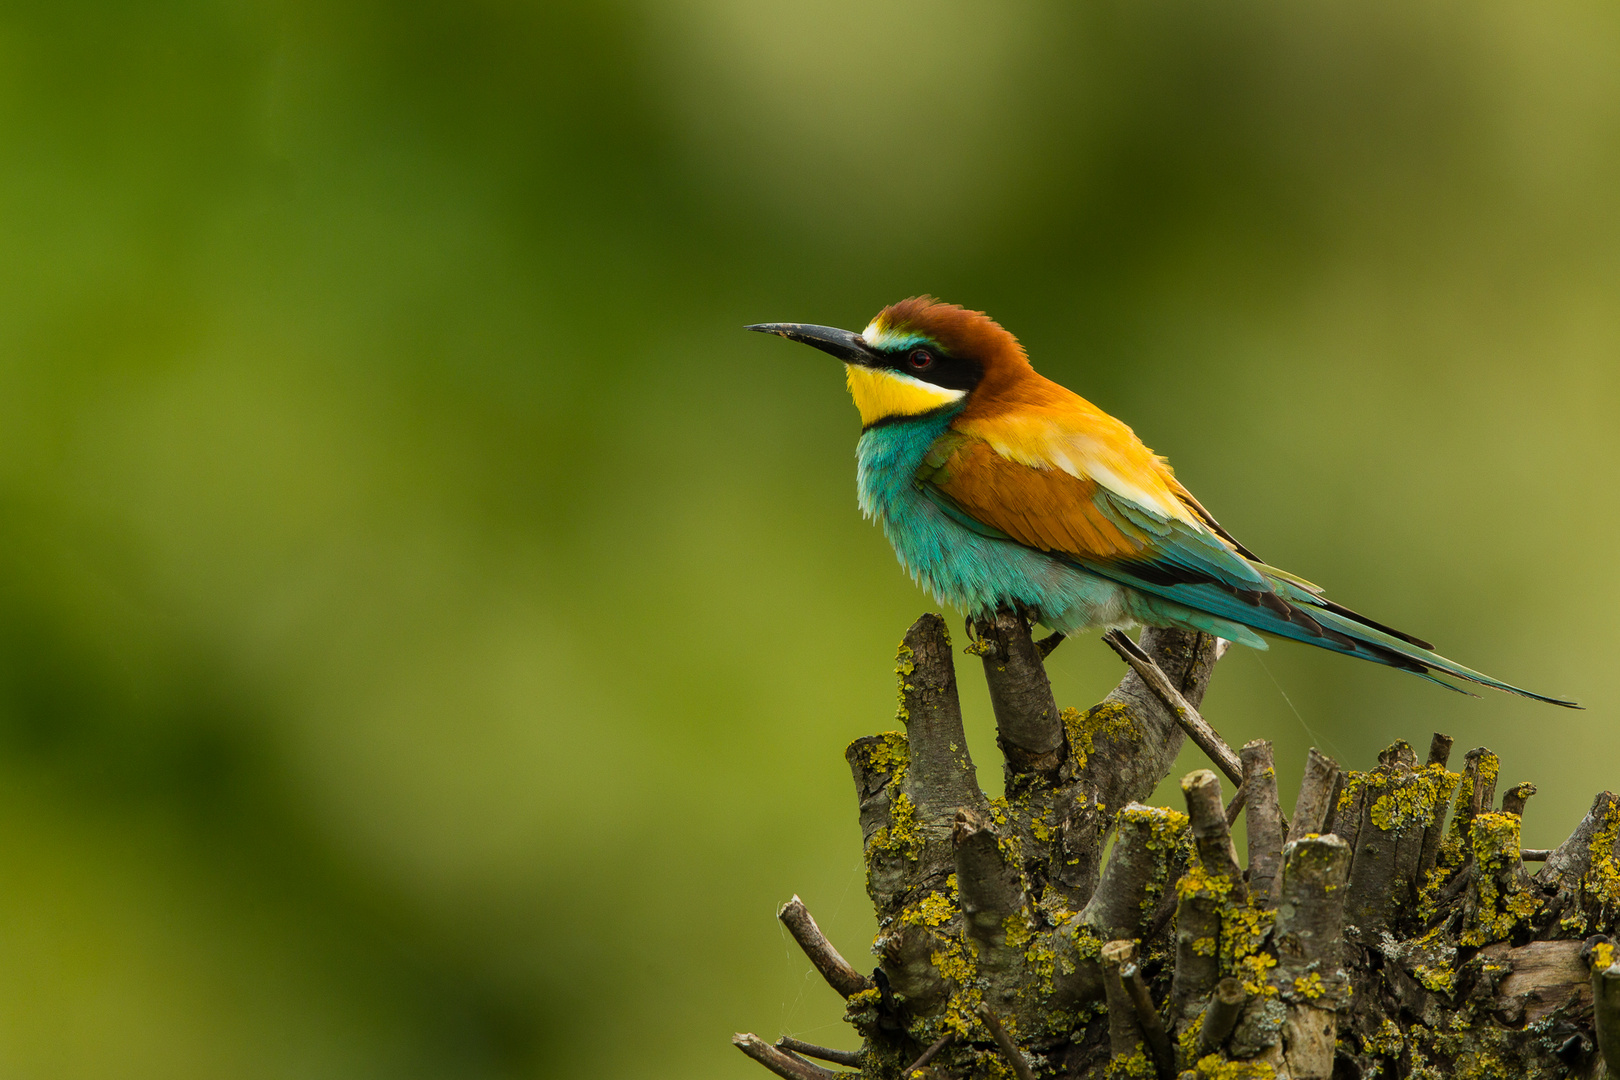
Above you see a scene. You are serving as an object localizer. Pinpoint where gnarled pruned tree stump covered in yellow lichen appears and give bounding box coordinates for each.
[734,610,1620,1080]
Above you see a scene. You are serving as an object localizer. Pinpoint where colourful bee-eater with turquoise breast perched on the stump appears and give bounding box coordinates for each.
[747,296,1580,708]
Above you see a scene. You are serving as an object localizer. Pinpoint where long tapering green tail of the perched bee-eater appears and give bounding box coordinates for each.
[1256,565,1583,709]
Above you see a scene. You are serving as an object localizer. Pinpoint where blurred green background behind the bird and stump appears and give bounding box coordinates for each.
[0,0,1620,1080]
